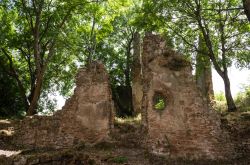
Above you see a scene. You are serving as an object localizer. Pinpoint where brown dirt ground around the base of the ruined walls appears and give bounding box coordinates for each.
[0,113,250,165]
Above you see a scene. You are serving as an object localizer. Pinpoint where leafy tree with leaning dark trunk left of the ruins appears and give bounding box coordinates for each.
[0,0,87,115]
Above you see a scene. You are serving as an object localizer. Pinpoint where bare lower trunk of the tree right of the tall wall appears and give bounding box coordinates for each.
[222,72,237,112]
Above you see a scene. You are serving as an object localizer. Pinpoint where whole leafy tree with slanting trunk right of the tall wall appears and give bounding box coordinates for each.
[141,0,249,111]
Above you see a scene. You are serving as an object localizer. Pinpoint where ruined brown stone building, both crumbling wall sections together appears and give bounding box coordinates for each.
[10,34,234,159]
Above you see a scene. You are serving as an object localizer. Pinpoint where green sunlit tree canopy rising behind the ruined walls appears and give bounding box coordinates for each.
[0,0,250,116]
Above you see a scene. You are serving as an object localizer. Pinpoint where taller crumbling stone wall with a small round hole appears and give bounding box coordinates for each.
[142,34,234,159]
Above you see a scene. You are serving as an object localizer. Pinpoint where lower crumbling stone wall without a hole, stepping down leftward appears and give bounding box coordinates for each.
[14,62,113,148]
